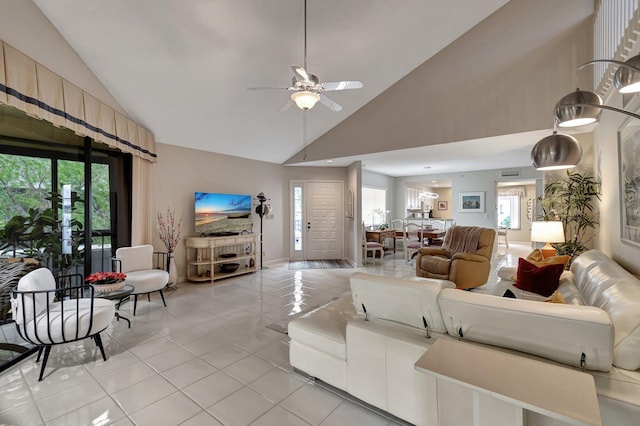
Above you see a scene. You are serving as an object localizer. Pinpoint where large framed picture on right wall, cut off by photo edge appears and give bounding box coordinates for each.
[618,121,640,245]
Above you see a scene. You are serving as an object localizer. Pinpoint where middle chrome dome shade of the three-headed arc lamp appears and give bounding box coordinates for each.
[554,89,602,127]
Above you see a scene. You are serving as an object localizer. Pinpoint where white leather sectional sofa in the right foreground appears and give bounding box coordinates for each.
[289,250,640,426]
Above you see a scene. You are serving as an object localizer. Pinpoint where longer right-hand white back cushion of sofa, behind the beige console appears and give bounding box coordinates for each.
[439,289,614,371]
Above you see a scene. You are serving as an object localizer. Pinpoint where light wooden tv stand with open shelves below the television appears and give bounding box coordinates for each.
[184,234,257,282]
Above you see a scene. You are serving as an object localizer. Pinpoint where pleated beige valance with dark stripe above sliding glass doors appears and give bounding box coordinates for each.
[0,42,157,162]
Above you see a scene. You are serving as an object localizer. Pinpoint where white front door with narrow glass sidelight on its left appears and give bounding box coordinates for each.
[291,182,343,260]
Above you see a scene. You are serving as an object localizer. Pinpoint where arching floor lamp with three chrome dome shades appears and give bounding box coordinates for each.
[531,55,640,170]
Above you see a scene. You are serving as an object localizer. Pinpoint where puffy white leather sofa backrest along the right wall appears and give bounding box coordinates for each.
[571,250,640,370]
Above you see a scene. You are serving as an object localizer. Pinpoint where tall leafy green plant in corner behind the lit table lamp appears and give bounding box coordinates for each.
[538,171,600,259]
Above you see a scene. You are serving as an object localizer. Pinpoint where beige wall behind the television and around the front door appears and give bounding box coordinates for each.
[153,144,350,277]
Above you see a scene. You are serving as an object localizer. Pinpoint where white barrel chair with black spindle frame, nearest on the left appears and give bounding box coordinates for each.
[11,268,116,381]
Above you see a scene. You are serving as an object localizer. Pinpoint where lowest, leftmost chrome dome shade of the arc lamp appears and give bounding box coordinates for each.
[531,131,582,170]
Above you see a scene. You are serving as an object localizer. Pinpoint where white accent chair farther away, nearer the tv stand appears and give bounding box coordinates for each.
[114,245,169,316]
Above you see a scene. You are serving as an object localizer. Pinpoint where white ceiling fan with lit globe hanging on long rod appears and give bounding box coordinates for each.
[248,0,363,112]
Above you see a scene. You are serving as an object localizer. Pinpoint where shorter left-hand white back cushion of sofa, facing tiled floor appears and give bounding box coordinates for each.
[350,272,455,333]
